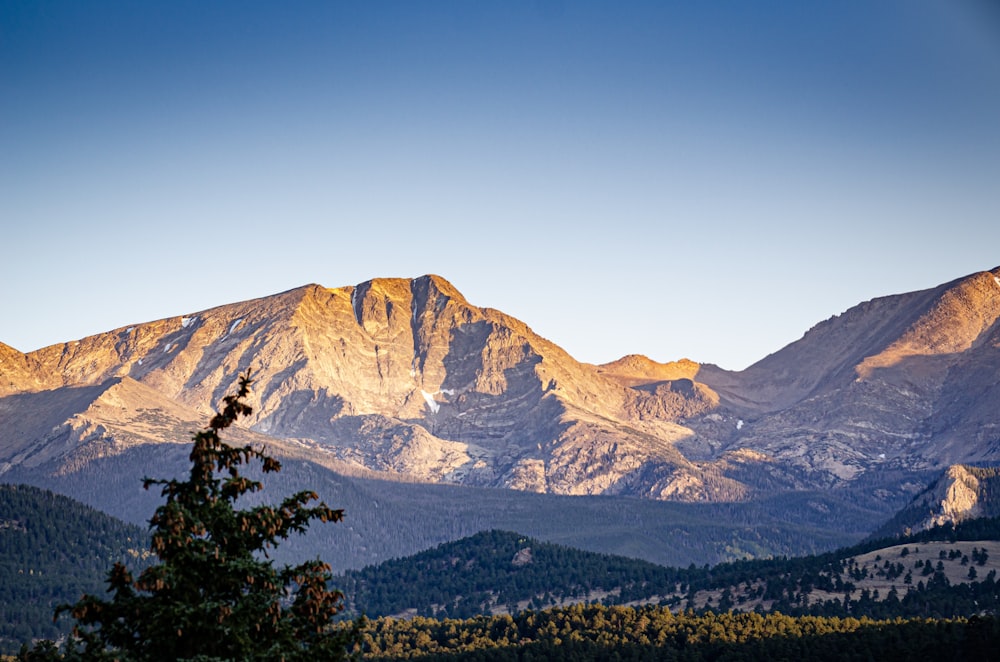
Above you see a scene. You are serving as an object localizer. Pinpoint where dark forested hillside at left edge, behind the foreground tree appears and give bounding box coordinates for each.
[0,484,148,652]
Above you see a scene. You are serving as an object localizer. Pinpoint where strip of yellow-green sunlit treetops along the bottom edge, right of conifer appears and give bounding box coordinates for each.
[358,604,1000,662]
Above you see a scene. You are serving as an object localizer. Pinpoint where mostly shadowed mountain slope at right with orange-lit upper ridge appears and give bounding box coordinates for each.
[686,268,1000,485]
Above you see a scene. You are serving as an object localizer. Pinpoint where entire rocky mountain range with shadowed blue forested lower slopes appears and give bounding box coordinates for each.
[0,268,1000,566]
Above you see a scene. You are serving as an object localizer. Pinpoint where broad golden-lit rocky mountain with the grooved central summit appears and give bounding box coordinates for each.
[0,276,718,499]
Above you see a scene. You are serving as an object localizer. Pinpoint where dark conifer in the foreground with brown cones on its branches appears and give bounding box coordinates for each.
[23,371,358,662]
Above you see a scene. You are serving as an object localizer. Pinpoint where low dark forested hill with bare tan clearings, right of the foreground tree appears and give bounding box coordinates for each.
[337,518,1000,618]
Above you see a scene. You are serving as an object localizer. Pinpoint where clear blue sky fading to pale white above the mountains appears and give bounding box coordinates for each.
[0,0,1000,369]
